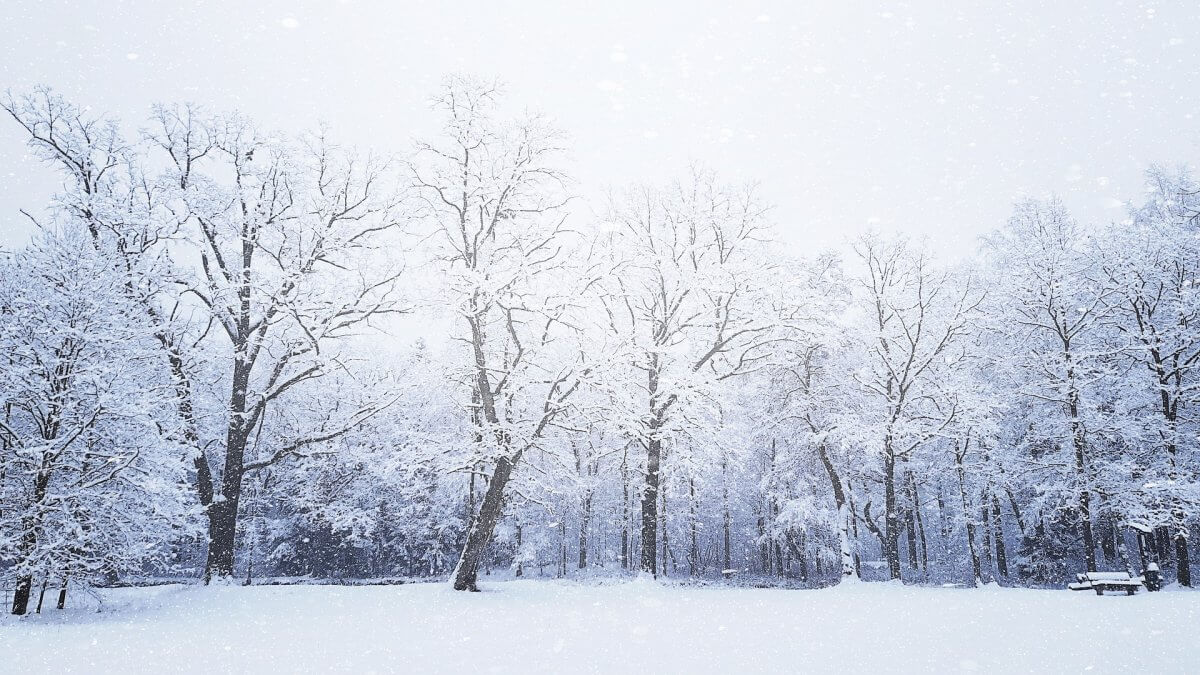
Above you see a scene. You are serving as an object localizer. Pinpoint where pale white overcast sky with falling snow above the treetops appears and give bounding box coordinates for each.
[0,0,1200,256]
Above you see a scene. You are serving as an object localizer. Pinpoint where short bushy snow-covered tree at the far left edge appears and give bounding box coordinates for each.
[0,228,193,614]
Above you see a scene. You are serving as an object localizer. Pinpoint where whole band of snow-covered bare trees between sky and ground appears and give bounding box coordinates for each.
[0,77,1200,614]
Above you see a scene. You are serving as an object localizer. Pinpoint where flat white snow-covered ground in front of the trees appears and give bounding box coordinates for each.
[0,581,1200,675]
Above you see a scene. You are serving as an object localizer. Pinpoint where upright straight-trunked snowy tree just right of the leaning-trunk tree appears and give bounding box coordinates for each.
[602,169,782,574]
